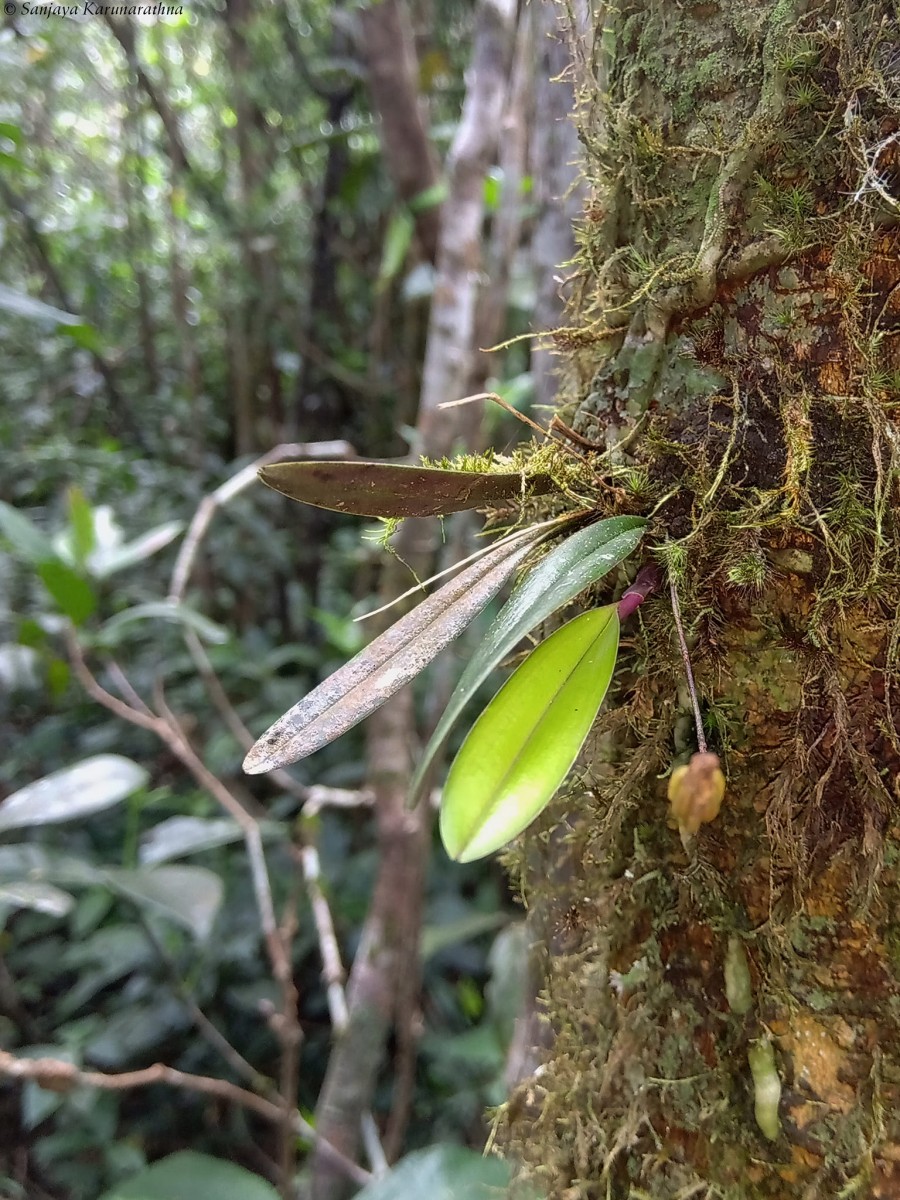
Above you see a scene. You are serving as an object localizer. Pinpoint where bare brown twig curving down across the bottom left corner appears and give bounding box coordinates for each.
[0,1050,372,1186]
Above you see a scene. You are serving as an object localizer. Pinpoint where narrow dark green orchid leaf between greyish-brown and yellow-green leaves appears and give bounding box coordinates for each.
[410,517,646,799]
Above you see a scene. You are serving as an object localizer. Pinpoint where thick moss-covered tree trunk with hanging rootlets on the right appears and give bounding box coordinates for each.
[499,0,900,1200]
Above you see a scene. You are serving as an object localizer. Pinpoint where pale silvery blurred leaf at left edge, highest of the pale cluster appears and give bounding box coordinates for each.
[0,754,148,830]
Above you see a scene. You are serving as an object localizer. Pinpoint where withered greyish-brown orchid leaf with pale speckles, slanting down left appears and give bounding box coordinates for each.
[244,526,547,775]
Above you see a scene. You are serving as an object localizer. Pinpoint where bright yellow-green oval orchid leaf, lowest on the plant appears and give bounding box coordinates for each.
[440,605,619,863]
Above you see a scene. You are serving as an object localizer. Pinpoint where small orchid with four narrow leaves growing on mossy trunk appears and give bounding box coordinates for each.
[244,462,655,862]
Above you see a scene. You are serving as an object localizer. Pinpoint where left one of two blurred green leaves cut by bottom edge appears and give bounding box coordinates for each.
[101,1150,278,1200]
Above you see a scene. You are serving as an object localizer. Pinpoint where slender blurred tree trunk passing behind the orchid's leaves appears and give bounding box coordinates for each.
[311,0,515,1200]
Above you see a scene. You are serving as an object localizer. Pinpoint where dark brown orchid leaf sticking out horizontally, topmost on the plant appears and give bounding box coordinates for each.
[259,461,556,517]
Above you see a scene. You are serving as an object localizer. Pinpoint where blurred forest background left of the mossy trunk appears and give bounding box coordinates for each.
[0,7,581,1200]
